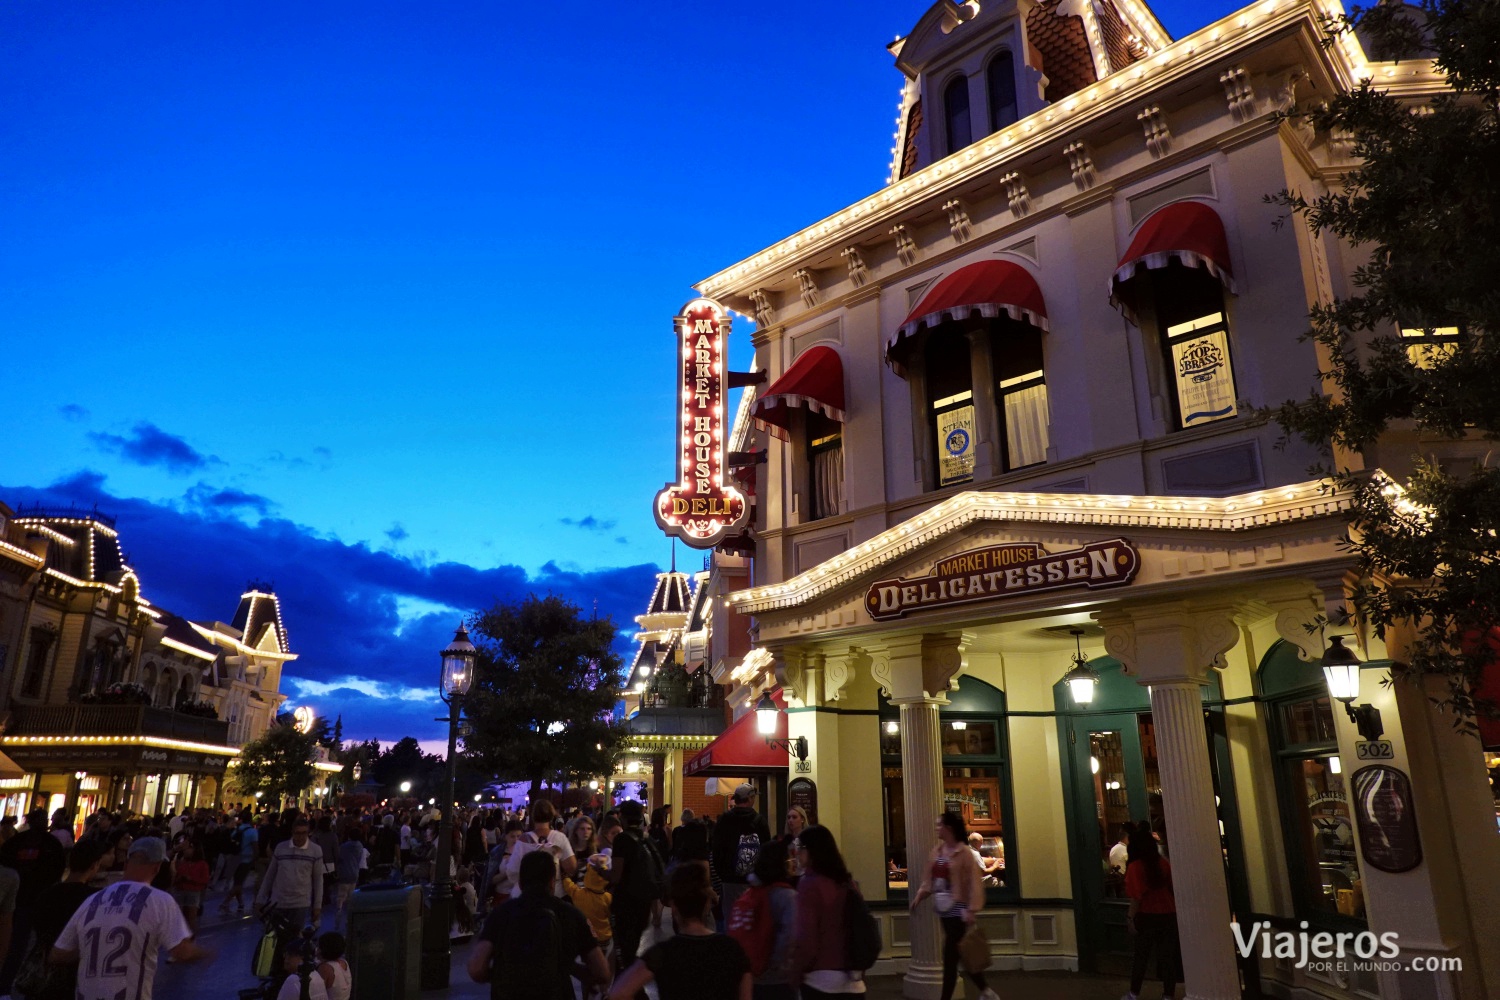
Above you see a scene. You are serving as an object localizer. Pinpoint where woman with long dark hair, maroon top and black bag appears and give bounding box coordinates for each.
[791,826,881,1000]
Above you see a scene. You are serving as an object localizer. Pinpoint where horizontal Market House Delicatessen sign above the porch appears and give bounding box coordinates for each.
[864,538,1140,621]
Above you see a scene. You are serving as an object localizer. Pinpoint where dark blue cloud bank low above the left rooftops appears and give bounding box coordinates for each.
[0,471,659,741]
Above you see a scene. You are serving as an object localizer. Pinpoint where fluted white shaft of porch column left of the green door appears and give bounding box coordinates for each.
[899,697,942,1000]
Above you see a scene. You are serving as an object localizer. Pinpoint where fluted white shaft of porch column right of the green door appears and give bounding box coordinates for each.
[1151,679,1241,1000]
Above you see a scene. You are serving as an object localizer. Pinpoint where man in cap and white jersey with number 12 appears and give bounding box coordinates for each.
[50,837,207,1000]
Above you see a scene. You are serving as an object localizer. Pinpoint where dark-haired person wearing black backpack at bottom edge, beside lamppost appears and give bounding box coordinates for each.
[468,850,609,1000]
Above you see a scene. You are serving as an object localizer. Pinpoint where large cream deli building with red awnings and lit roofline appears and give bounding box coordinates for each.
[672,0,1500,1000]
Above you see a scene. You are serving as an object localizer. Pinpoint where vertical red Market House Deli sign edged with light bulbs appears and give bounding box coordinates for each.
[656,298,750,549]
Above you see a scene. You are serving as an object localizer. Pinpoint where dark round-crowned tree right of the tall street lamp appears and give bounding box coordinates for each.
[464,595,624,798]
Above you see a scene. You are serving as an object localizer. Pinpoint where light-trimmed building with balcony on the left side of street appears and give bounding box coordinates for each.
[0,507,296,823]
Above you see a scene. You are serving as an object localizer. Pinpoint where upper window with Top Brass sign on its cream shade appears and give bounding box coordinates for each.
[1152,261,1239,429]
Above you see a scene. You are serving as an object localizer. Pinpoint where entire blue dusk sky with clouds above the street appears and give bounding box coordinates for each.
[0,0,1241,741]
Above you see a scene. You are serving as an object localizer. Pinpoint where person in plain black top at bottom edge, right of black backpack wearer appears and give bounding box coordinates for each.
[609,861,753,1000]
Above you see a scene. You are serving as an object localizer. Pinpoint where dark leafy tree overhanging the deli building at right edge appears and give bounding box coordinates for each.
[1272,0,1500,730]
